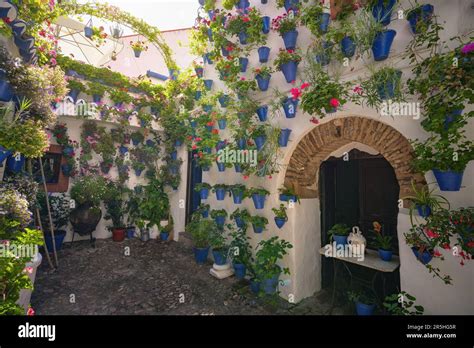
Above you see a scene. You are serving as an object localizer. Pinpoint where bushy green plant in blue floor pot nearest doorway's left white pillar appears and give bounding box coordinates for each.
[255,236,293,295]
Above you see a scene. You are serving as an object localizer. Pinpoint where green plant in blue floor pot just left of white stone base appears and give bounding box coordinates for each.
[186,219,217,264]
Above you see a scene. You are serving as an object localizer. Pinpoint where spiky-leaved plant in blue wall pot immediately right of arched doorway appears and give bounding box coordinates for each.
[402,180,449,225]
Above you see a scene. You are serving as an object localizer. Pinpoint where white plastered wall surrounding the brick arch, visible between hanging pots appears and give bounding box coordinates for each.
[198,0,474,314]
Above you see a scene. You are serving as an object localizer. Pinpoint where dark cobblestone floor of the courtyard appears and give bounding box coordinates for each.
[31,239,344,315]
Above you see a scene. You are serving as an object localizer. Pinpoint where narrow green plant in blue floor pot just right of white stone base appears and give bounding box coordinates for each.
[229,229,253,279]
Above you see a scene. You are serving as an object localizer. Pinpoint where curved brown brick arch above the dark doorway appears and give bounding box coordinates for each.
[284,116,425,199]
